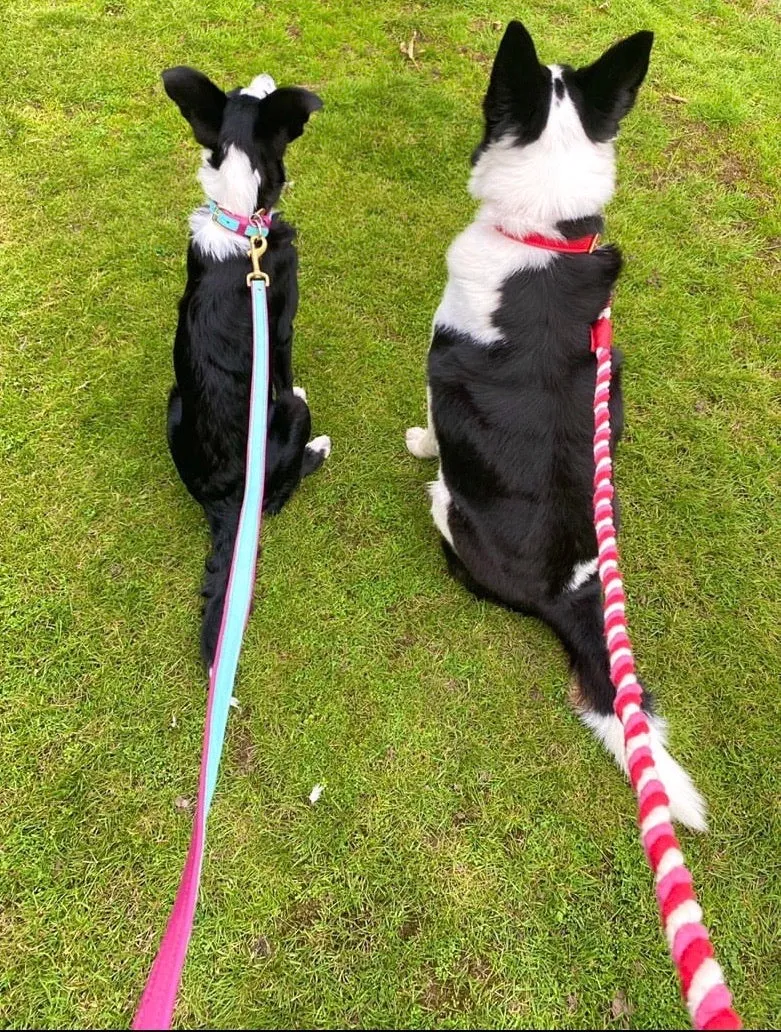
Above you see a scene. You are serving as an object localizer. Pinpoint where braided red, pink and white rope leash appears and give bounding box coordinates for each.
[591,307,743,1029]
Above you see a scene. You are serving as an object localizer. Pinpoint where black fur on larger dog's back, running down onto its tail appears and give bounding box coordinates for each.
[428,247,623,713]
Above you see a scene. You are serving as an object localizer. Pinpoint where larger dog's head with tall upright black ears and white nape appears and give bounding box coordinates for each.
[470,22,653,229]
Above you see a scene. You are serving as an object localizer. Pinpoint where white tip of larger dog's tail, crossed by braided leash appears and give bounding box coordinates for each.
[579,710,708,832]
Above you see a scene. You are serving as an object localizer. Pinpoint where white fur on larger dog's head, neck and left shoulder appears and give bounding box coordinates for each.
[434,65,615,345]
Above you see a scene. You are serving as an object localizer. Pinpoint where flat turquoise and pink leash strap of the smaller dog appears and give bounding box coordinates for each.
[133,279,268,1029]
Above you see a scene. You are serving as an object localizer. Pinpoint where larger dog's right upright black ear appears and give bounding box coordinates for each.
[573,32,653,139]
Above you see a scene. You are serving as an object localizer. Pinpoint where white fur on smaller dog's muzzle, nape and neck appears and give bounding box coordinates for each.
[190,74,276,261]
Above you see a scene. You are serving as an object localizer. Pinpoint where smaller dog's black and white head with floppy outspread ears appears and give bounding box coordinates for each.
[163,66,323,216]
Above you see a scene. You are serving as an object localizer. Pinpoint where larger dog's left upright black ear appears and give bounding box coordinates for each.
[483,22,550,142]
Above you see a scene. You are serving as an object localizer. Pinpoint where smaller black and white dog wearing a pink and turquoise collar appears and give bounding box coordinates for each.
[163,67,331,669]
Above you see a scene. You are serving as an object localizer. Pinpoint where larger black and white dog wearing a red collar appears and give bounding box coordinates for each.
[406,22,705,830]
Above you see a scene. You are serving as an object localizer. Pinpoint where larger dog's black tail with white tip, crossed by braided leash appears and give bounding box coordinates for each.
[540,577,706,831]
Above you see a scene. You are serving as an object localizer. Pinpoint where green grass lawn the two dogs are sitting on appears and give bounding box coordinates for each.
[0,0,781,1029]
